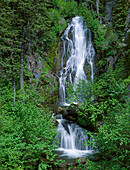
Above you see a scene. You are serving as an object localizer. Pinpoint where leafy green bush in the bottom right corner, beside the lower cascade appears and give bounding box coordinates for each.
[88,103,130,170]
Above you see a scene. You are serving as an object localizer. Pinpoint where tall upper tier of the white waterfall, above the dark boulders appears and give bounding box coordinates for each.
[59,16,95,105]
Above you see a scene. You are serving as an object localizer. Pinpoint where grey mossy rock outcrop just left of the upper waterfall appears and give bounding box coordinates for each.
[27,54,58,103]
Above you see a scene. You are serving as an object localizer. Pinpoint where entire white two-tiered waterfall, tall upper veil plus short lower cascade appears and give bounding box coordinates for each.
[56,16,95,161]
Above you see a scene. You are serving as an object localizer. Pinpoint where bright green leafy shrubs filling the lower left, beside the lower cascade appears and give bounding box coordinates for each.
[0,89,56,169]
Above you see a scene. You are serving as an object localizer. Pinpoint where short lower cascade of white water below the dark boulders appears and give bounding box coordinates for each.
[56,115,93,159]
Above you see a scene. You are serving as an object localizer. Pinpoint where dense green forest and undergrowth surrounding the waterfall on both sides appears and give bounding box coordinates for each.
[0,0,130,170]
